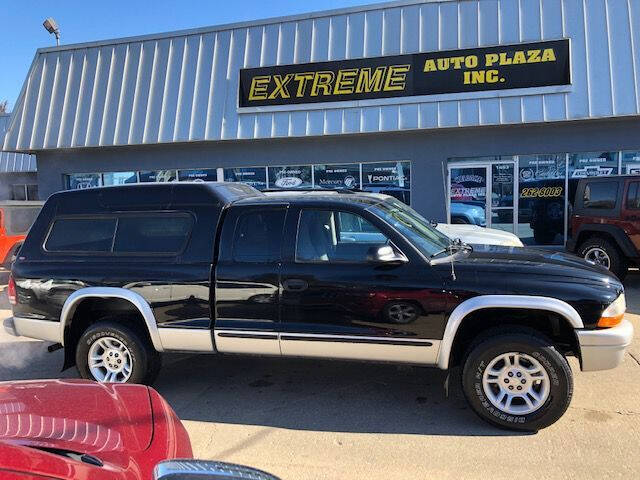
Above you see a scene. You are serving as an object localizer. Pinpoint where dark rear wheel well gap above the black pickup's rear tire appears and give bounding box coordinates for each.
[63,297,152,370]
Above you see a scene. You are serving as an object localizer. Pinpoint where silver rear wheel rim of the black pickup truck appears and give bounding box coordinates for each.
[88,337,133,383]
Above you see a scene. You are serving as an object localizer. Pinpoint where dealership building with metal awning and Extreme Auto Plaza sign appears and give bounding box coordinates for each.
[2,0,640,245]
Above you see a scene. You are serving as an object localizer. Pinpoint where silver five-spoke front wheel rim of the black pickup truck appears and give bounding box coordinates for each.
[482,352,551,415]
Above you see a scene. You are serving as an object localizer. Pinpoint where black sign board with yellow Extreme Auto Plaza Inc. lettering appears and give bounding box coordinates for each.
[239,39,571,107]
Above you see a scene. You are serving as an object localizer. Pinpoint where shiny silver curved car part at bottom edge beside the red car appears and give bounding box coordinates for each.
[153,459,280,480]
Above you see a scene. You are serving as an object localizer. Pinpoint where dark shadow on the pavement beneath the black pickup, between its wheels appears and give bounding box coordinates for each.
[155,355,518,436]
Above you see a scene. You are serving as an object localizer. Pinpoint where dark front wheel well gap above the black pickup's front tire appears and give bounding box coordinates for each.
[449,308,580,367]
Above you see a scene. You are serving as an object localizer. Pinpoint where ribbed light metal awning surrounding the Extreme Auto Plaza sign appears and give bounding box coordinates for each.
[2,0,640,153]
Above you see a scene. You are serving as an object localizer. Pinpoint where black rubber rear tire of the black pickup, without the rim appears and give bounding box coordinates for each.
[76,320,162,385]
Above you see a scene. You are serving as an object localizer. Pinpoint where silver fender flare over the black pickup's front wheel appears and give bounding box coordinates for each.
[438,295,584,370]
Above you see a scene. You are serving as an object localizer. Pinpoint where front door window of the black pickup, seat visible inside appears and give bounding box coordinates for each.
[296,209,388,263]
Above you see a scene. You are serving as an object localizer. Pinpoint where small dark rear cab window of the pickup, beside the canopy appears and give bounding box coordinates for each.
[233,209,285,263]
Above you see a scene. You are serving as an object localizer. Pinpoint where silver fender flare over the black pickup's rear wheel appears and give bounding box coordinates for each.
[60,287,164,352]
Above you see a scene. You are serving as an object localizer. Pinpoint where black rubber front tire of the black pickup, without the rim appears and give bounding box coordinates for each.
[462,327,573,432]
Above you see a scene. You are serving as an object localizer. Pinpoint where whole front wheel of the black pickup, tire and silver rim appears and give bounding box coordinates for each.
[462,328,573,431]
